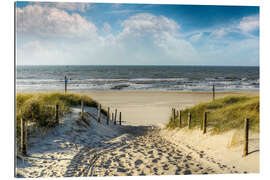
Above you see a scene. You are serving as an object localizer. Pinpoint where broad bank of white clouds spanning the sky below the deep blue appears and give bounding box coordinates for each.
[16,3,259,65]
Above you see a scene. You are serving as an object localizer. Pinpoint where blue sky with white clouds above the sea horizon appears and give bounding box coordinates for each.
[16,2,259,66]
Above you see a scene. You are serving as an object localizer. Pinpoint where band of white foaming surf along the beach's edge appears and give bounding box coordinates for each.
[16,78,259,91]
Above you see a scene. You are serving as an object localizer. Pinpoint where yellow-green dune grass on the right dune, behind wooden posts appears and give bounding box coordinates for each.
[167,96,260,134]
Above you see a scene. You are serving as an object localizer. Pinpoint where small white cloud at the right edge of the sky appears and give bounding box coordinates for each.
[239,15,259,32]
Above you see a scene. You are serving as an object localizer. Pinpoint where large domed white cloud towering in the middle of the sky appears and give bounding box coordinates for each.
[114,13,198,64]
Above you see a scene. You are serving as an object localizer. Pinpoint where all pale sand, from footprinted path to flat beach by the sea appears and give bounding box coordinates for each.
[16,91,259,177]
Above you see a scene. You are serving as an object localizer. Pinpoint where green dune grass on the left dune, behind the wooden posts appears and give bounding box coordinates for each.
[16,92,107,149]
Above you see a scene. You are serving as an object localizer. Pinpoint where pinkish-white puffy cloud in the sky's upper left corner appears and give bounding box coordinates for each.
[16,5,97,38]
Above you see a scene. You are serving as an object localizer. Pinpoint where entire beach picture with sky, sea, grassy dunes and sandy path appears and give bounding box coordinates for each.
[14,2,260,178]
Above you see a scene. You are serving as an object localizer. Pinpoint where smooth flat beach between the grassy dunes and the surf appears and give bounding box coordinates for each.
[82,91,259,128]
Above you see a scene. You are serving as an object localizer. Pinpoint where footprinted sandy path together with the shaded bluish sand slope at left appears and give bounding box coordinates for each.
[16,108,236,178]
